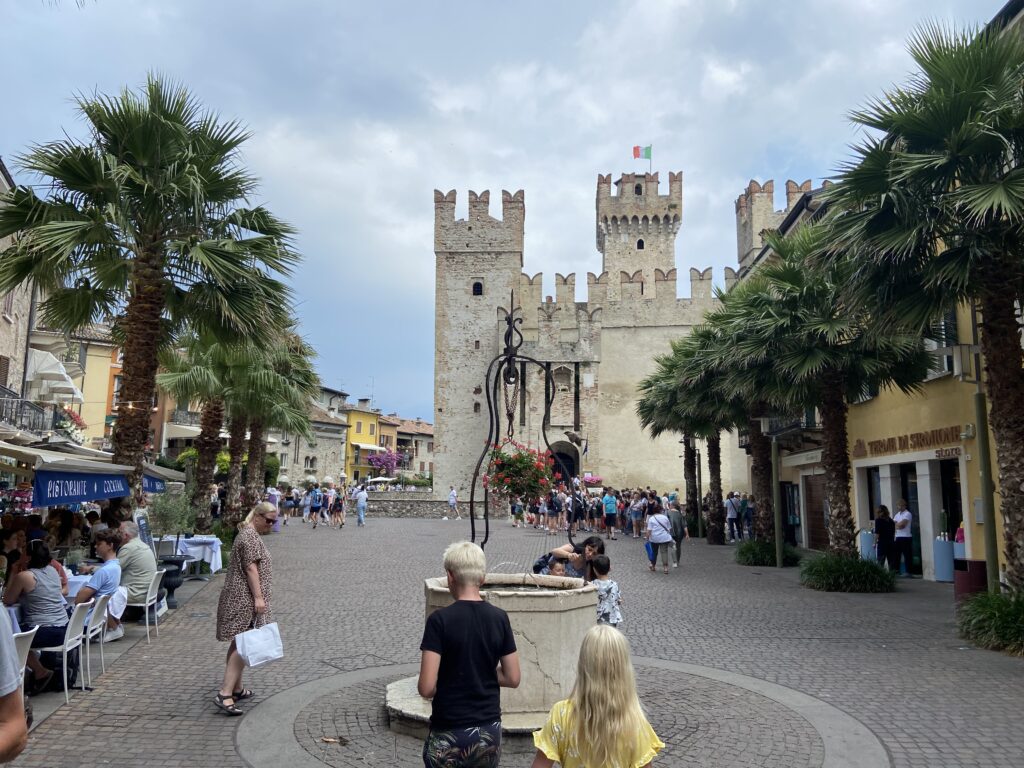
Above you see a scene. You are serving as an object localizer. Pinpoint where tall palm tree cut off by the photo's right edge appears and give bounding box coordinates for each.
[828,26,1024,589]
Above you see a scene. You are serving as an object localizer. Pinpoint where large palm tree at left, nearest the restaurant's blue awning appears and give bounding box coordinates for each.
[0,76,298,495]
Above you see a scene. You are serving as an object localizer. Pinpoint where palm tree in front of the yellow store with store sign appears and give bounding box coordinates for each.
[724,223,930,555]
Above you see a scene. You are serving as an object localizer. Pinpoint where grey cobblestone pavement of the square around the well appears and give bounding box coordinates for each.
[14,515,1024,768]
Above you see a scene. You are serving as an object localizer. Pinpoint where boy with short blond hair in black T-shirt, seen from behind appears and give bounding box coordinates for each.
[417,542,520,768]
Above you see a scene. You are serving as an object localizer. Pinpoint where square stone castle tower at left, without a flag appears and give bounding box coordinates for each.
[434,189,525,500]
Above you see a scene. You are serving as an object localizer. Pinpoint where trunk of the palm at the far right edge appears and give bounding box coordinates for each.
[980,286,1024,591]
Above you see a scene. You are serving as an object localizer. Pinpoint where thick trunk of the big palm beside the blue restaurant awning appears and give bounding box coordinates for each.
[112,251,164,518]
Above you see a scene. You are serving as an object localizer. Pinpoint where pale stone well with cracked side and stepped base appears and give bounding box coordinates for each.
[386,573,597,736]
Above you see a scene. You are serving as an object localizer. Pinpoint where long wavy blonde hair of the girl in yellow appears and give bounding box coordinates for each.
[568,624,647,768]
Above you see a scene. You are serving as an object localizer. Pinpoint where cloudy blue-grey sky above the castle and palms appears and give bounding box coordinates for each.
[0,0,1004,419]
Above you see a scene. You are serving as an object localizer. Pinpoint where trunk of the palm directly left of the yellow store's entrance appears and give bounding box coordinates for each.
[818,372,857,557]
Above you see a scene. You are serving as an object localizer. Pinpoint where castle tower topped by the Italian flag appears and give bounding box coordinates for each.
[597,172,683,301]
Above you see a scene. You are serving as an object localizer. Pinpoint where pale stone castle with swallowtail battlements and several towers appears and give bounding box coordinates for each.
[434,173,809,499]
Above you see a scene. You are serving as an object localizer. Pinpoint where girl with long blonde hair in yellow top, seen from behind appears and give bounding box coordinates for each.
[532,624,665,768]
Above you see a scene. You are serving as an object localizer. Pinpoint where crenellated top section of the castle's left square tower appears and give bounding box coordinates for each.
[434,189,526,254]
